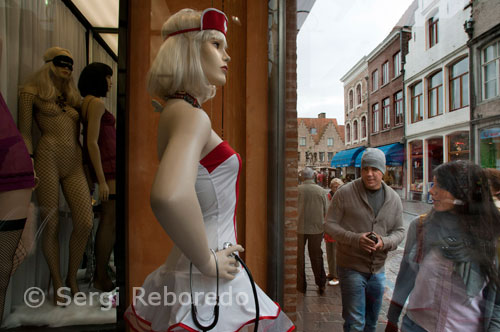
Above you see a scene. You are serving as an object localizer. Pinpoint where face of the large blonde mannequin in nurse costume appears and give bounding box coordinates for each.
[200,38,231,86]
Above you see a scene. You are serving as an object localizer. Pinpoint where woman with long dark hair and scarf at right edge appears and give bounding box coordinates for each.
[386,160,500,332]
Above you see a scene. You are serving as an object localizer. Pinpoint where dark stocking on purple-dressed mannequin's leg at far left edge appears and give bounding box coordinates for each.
[0,228,23,325]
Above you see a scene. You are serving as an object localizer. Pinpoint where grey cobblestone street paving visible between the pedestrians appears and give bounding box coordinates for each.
[296,201,431,332]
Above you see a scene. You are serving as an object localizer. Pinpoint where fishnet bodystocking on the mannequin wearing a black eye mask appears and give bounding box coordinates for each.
[19,92,92,294]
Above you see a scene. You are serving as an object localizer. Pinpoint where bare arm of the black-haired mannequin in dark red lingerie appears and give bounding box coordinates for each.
[86,98,109,201]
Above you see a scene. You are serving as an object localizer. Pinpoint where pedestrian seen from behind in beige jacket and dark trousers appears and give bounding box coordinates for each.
[297,168,327,295]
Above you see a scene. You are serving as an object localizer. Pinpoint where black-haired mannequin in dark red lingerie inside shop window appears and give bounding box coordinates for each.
[78,62,116,291]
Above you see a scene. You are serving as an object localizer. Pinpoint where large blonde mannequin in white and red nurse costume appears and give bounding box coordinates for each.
[125,8,293,331]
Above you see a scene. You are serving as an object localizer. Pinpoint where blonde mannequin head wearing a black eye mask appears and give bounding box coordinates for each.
[25,46,80,107]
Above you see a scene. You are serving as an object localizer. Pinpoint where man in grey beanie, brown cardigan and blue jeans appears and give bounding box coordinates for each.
[325,148,405,332]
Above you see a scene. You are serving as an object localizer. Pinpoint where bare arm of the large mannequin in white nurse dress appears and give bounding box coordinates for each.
[151,103,243,279]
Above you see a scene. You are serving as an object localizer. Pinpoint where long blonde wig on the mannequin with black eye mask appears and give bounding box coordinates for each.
[21,46,81,107]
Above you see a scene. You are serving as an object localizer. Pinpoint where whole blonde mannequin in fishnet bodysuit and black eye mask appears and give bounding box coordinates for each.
[18,47,92,304]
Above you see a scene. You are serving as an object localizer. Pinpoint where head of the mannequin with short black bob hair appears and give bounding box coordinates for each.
[78,62,113,97]
